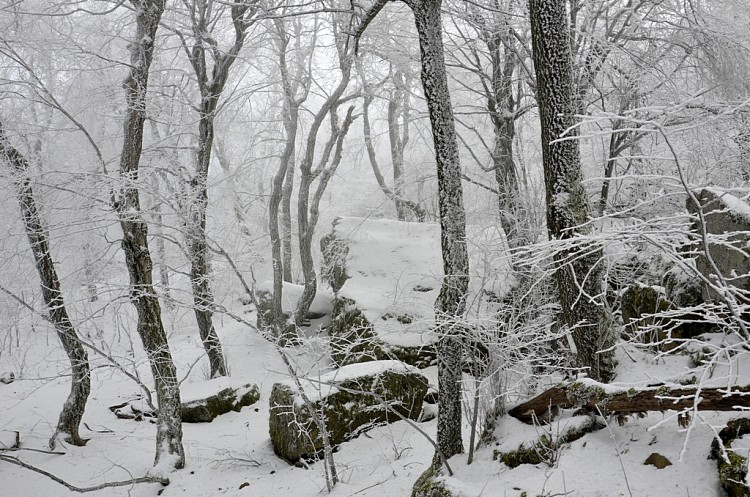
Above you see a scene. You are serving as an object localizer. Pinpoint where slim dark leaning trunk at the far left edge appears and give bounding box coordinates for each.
[0,123,91,449]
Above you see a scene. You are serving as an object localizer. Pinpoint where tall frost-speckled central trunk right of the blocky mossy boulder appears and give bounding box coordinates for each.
[406,0,469,464]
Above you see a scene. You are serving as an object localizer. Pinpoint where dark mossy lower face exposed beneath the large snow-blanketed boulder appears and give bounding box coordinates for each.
[328,297,437,368]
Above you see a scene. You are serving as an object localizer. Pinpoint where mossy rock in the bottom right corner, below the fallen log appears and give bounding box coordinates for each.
[710,418,750,497]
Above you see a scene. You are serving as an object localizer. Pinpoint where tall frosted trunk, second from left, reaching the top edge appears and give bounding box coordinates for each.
[116,0,185,469]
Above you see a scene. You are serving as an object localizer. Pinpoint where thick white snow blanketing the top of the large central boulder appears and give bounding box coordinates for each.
[334,217,514,347]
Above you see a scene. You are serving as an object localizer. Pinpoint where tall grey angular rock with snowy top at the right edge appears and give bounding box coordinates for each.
[687,188,750,302]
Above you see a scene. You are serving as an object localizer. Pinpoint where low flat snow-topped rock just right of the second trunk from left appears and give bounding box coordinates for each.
[180,376,260,423]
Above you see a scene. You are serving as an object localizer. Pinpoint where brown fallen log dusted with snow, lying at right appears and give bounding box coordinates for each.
[508,379,750,424]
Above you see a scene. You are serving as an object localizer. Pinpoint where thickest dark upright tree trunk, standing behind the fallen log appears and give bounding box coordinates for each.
[529,0,614,381]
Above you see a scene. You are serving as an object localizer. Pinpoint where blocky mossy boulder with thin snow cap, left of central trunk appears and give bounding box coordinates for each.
[269,361,427,462]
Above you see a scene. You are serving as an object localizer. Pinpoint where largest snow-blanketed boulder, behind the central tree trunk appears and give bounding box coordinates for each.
[321,217,514,367]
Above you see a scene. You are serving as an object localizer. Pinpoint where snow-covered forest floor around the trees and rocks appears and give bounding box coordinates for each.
[0,298,747,497]
